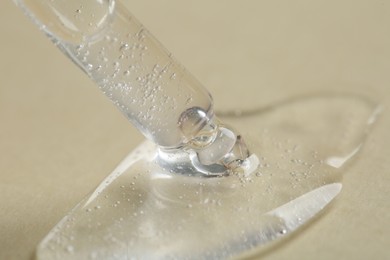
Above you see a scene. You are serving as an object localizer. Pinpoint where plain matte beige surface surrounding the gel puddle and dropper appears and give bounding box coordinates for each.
[0,0,390,259]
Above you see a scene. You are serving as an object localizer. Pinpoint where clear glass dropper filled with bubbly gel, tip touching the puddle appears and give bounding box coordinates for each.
[15,0,248,174]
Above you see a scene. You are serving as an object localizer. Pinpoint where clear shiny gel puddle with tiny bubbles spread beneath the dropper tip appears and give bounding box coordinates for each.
[37,95,380,259]
